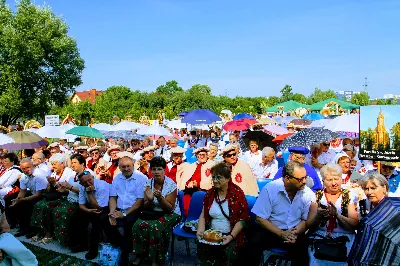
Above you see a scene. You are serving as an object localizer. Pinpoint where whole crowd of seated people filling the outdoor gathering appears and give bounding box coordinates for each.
[0,125,400,266]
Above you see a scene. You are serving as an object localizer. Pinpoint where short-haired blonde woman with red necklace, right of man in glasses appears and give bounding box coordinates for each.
[307,163,359,265]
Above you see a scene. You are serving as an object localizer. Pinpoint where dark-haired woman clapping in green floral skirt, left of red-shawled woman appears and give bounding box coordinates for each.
[132,156,181,266]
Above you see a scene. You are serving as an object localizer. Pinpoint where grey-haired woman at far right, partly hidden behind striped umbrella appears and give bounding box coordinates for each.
[359,172,389,217]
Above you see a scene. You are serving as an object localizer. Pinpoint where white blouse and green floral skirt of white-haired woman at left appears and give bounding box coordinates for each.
[31,167,79,245]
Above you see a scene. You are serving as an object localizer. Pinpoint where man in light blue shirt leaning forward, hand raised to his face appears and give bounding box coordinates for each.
[71,171,110,260]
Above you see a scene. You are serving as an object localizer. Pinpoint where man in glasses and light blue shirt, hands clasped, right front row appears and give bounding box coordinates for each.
[245,161,315,266]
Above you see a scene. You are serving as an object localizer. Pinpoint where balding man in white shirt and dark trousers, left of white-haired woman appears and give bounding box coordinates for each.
[7,158,48,237]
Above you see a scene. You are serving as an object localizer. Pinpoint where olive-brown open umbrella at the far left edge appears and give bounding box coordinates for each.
[0,131,48,150]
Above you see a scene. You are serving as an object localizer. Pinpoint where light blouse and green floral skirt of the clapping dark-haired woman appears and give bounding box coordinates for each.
[132,176,181,263]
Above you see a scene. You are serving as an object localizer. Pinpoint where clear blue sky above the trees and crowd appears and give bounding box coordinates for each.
[8,0,400,97]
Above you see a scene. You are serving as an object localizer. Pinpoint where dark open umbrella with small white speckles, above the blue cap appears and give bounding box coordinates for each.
[278,128,338,150]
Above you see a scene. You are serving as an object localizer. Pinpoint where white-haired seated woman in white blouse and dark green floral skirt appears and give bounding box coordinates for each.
[31,153,79,245]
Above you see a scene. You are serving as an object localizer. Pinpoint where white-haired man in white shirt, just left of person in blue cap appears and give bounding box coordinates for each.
[252,147,278,179]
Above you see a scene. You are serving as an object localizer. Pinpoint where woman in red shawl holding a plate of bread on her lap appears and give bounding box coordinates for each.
[197,162,250,265]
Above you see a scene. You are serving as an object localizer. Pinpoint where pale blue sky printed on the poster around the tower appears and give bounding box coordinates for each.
[360,105,400,133]
